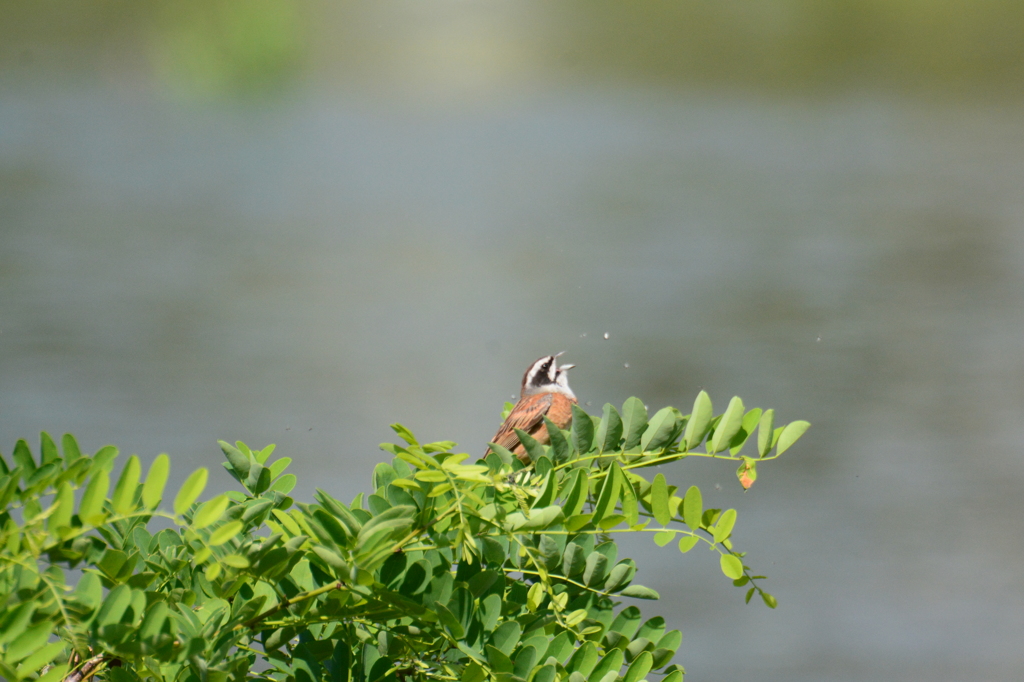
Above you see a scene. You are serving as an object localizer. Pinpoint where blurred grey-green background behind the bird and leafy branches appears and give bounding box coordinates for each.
[0,0,1024,681]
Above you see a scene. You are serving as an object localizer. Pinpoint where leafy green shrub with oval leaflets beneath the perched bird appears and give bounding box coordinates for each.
[0,393,807,682]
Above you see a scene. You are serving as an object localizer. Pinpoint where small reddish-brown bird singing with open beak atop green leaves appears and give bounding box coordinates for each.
[487,351,577,464]
